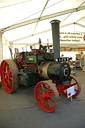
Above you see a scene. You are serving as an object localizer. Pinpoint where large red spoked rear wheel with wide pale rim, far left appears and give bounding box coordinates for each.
[1,59,19,93]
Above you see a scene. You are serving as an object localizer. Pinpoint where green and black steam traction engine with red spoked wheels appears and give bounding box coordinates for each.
[1,21,81,112]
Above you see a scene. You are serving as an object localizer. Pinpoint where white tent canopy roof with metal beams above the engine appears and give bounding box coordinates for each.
[0,0,85,44]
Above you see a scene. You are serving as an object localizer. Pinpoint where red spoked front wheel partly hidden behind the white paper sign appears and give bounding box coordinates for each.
[62,76,81,98]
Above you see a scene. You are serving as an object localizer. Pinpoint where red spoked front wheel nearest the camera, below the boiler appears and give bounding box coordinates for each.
[35,81,56,112]
